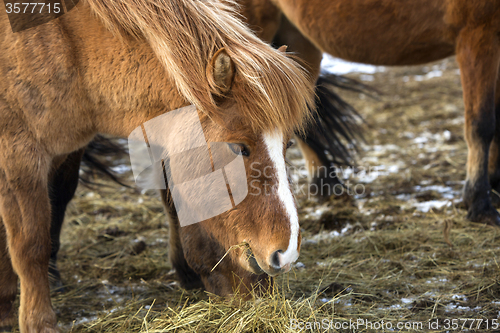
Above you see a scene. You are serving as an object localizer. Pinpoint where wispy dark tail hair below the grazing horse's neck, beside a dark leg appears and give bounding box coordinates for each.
[80,135,128,187]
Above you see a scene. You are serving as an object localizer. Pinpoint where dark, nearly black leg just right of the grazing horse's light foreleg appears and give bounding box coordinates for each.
[49,149,85,291]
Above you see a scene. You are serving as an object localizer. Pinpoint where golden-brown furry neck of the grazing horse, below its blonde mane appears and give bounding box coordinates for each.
[63,6,188,136]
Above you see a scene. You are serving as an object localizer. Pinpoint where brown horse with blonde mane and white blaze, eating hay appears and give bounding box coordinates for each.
[0,0,313,332]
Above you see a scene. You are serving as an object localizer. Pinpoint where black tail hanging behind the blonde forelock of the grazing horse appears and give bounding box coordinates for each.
[304,73,377,166]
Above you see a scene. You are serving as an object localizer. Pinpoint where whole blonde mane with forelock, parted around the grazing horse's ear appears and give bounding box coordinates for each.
[86,0,313,131]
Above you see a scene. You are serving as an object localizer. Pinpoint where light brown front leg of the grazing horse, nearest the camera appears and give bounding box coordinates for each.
[0,145,58,333]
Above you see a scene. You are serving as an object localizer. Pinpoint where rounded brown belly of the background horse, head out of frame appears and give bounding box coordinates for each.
[280,0,454,65]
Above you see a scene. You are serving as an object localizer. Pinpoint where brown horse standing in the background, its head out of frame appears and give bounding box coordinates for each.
[239,0,500,226]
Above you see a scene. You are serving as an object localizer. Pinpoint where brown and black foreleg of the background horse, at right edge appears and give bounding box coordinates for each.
[457,27,500,226]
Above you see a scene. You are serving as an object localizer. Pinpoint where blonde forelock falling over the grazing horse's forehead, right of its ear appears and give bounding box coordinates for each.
[228,45,313,133]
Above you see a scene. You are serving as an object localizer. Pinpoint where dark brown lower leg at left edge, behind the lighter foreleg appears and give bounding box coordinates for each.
[0,216,17,332]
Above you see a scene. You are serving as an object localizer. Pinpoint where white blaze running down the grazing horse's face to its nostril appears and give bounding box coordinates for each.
[263,130,299,267]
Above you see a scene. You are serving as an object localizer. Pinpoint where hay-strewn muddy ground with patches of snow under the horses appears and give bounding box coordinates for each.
[6,59,500,332]
